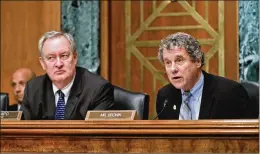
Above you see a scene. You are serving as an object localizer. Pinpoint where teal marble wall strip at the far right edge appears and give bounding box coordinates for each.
[239,1,259,82]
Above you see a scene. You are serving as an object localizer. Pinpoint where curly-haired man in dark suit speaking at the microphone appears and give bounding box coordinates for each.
[156,32,249,120]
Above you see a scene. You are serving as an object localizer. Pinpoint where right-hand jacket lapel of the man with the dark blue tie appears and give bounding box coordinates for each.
[64,67,84,119]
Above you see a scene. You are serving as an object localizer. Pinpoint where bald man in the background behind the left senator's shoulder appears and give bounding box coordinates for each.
[8,68,35,111]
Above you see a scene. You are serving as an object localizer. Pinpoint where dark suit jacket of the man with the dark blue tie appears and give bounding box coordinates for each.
[21,67,114,120]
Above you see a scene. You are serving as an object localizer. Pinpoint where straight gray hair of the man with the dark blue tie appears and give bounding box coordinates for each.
[38,31,76,56]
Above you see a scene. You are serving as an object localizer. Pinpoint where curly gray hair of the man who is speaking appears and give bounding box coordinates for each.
[158,32,205,67]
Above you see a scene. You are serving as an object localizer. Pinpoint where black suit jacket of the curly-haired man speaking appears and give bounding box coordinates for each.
[156,71,249,119]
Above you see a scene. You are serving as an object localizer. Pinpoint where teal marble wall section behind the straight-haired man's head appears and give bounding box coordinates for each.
[61,0,100,73]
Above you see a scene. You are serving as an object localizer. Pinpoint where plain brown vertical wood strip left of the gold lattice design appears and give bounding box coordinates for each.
[109,1,126,88]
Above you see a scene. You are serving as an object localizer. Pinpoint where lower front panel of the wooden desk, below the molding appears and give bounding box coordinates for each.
[1,136,259,153]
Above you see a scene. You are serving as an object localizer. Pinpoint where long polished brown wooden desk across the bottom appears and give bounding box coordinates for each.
[1,120,259,153]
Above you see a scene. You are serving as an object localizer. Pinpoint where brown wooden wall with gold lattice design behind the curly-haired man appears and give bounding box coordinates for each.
[106,1,238,118]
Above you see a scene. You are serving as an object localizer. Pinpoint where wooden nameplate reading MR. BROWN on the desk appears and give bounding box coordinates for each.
[85,110,138,120]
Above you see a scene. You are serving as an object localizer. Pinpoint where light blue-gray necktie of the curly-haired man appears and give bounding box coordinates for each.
[179,92,192,120]
